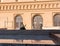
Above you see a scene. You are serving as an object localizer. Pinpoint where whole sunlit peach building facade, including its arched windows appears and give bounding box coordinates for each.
[0,0,60,30]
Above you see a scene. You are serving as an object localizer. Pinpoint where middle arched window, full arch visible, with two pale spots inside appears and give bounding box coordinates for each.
[33,15,43,30]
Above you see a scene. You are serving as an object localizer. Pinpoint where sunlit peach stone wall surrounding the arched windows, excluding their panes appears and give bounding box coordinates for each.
[0,0,60,30]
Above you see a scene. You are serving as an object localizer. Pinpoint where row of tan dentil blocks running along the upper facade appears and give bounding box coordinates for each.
[0,3,60,10]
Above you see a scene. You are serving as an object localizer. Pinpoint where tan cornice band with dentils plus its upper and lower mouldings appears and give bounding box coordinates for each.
[0,2,60,11]
